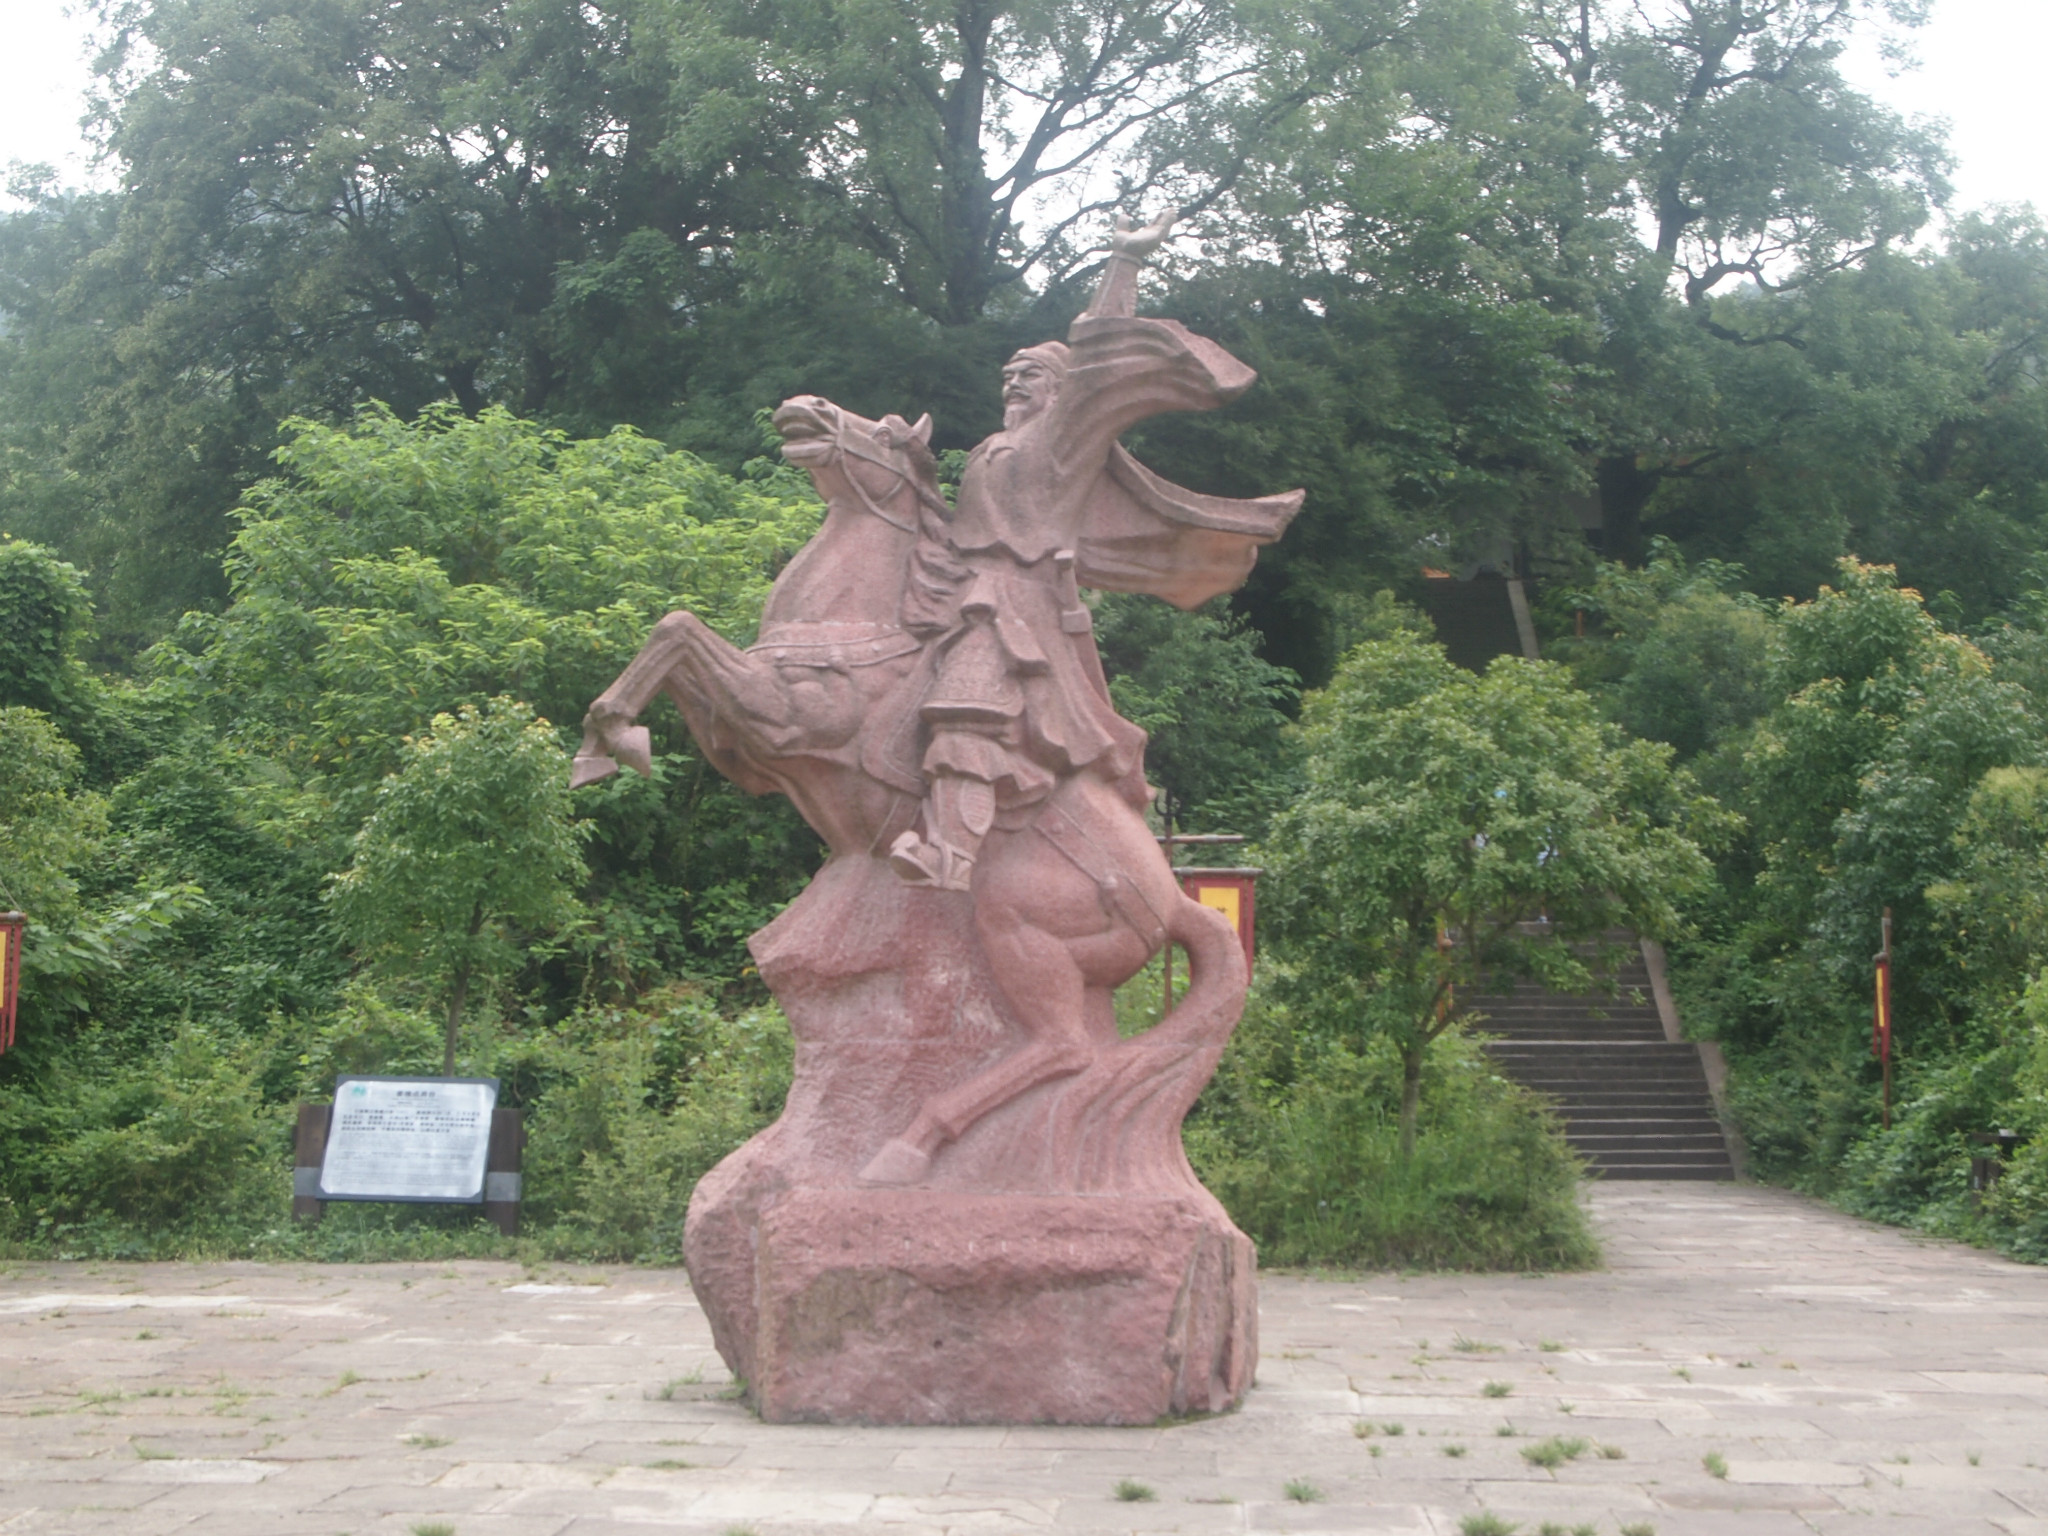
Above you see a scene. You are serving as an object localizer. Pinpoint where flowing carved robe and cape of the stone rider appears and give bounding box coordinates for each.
[862,315,1300,815]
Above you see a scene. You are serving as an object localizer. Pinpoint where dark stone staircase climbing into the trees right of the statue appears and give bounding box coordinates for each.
[1464,952,1735,1180]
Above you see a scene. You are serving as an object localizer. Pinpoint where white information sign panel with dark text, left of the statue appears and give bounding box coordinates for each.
[317,1077,498,1204]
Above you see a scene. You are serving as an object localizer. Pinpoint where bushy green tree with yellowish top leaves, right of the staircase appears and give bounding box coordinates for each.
[1675,561,2048,1190]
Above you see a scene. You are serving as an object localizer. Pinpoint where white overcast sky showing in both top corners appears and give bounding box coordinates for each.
[0,0,2048,231]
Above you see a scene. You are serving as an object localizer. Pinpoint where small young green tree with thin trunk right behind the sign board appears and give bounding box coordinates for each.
[330,698,586,1077]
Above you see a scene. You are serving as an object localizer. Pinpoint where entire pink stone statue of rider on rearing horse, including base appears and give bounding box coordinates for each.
[575,217,1300,1423]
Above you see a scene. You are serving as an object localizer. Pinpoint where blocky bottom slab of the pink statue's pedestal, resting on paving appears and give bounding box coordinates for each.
[690,1190,1257,1423]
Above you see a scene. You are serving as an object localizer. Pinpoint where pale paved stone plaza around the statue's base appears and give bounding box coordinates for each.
[0,1184,2048,1536]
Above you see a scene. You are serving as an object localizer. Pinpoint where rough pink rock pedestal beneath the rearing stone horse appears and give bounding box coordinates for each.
[684,858,1257,1423]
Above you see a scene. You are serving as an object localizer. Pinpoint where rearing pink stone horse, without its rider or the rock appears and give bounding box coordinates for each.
[573,395,1243,1184]
